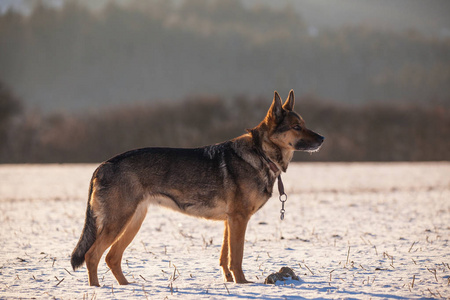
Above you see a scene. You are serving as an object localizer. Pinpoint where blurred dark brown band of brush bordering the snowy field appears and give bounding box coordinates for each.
[0,79,450,163]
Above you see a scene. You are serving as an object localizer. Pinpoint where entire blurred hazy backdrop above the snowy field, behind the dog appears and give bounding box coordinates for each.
[0,0,450,163]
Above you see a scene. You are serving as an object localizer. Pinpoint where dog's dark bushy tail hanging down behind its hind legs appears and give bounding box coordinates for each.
[70,179,97,271]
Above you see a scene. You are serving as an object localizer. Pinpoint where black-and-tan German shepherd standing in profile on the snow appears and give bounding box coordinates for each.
[71,90,324,286]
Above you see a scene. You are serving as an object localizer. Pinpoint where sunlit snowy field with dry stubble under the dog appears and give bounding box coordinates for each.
[0,162,450,299]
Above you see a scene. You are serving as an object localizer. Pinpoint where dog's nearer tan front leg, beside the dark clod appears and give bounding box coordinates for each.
[226,215,250,283]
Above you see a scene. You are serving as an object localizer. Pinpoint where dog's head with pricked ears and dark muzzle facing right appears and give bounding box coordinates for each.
[263,90,324,152]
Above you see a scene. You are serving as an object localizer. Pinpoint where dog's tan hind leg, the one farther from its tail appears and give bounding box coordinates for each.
[106,203,147,285]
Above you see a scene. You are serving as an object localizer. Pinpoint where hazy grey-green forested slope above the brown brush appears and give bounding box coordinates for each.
[0,0,450,111]
